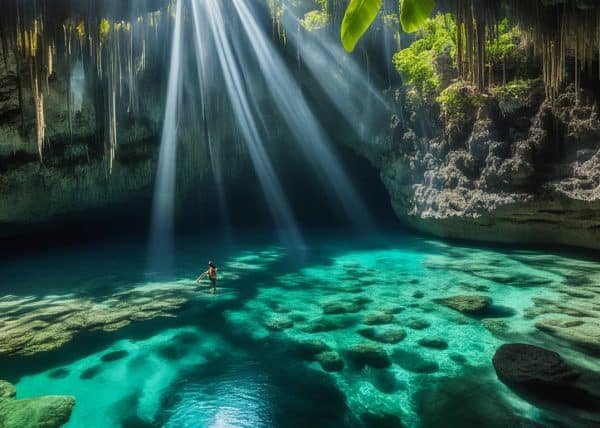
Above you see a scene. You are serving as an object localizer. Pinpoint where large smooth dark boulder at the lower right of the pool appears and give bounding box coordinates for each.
[492,343,600,411]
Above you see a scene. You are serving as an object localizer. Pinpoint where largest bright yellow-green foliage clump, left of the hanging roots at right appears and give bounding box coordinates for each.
[393,14,456,104]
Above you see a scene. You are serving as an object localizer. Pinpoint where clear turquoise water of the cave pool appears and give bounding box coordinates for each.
[0,232,600,427]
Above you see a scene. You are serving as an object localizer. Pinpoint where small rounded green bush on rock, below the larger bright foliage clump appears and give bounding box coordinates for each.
[436,81,482,122]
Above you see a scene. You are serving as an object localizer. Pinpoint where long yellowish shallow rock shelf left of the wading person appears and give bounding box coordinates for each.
[0,283,195,356]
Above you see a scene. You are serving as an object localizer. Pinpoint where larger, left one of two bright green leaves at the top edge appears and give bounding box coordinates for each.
[341,0,383,52]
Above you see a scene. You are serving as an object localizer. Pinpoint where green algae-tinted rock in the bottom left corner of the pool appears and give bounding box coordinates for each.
[0,381,75,428]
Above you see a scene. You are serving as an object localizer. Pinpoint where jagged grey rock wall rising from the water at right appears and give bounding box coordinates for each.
[366,82,600,248]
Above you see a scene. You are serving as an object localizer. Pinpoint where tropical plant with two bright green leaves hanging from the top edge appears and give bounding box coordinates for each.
[340,0,435,52]
